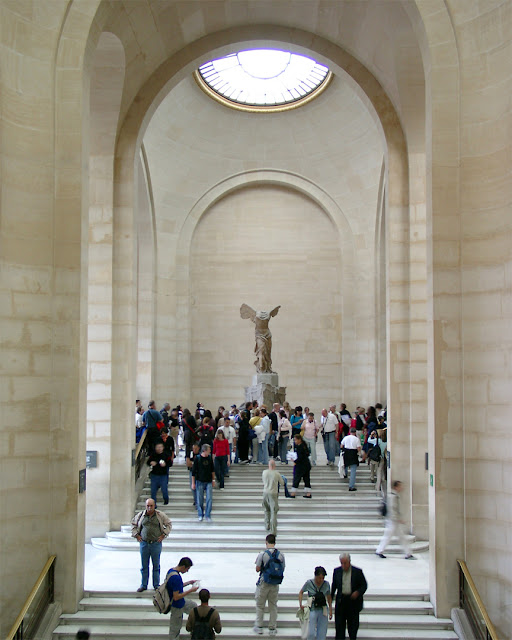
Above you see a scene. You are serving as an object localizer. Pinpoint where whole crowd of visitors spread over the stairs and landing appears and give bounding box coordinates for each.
[126,400,402,640]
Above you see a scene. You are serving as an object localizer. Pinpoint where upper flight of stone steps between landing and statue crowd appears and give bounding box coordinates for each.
[91,464,428,554]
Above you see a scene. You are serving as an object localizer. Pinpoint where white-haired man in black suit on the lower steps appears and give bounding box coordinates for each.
[331,553,368,640]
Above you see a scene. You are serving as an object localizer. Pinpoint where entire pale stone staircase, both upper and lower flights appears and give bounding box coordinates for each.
[54,460,457,640]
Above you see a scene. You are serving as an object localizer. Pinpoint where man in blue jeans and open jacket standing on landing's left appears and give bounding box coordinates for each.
[132,498,172,592]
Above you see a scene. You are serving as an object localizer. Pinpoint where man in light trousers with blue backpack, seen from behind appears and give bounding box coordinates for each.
[253,533,285,636]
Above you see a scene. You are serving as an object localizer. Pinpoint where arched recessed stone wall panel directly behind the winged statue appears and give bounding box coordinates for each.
[190,185,343,415]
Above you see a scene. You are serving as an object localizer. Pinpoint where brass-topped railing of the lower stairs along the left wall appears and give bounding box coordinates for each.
[7,556,57,640]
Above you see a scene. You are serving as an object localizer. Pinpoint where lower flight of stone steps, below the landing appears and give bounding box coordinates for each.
[54,592,457,640]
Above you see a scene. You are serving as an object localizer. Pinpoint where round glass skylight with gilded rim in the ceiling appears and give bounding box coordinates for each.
[196,49,331,111]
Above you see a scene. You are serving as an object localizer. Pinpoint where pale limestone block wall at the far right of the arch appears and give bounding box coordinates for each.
[452,2,512,638]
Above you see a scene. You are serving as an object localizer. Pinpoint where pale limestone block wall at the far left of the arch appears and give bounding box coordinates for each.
[0,1,94,637]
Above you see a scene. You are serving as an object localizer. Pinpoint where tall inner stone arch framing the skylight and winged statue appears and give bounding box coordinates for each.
[112,25,412,526]
